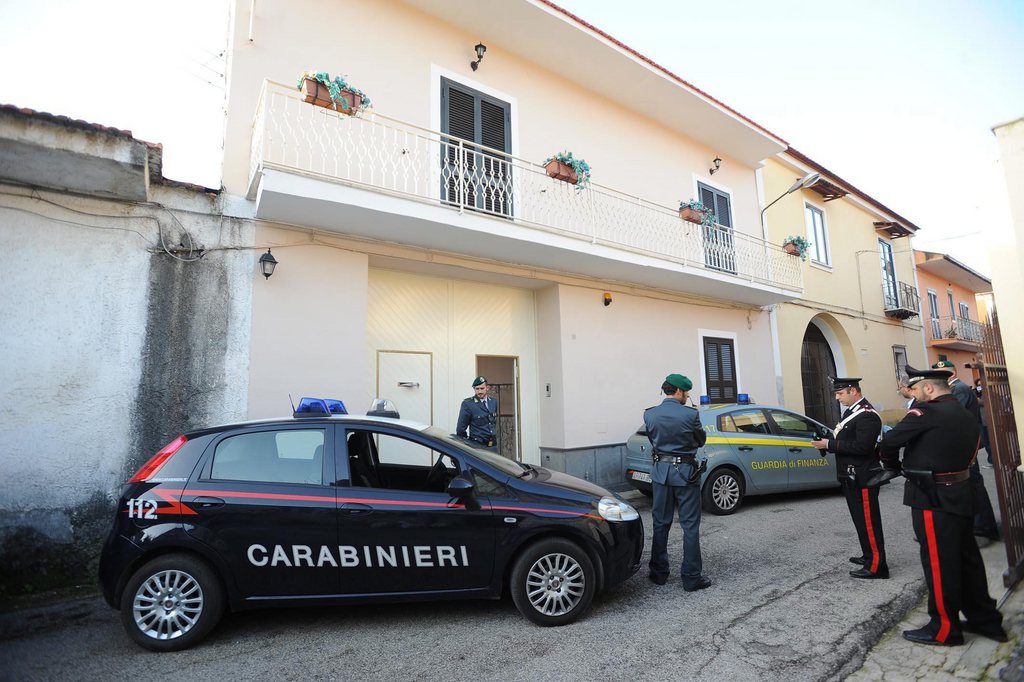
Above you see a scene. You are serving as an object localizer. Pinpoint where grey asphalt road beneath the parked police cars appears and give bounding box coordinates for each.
[0,479,929,682]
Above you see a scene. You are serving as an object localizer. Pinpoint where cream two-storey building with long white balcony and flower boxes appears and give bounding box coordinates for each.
[224,0,802,483]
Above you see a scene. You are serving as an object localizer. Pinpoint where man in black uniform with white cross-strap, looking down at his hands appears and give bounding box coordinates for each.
[811,377,889,580]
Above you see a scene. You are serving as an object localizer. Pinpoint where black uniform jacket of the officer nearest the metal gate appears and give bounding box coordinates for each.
[881,394,980,516]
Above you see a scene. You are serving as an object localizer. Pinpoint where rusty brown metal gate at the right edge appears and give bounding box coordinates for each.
[977,312,1024,588]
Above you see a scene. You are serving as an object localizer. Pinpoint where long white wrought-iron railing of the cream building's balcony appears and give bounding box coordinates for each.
[249,81,803,291]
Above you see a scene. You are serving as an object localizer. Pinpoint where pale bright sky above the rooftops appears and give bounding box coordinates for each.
[0,0,1024,274]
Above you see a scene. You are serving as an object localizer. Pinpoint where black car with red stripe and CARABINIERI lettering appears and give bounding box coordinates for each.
[99,398,643,651]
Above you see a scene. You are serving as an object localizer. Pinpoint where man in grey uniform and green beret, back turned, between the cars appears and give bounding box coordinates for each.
[643,374,711,592]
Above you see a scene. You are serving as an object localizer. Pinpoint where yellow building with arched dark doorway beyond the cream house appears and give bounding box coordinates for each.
[762,147,927,424]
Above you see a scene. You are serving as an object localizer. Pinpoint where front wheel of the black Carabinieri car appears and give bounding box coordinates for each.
[511,539,596,626]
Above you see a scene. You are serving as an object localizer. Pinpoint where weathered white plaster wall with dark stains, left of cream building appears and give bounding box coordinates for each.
[0,183,255,596]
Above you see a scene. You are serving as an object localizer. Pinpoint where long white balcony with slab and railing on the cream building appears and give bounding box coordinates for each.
[249,82,803,305]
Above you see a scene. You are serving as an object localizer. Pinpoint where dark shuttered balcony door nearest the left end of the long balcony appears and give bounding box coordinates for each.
[441,78,512,216]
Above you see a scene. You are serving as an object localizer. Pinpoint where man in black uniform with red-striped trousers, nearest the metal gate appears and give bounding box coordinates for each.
[877,366,1007,646]
